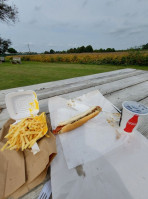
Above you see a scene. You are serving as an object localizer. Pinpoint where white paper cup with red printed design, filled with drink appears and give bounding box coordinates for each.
[120,101,148,133]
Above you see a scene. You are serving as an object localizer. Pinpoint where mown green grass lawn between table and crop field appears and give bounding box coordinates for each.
[0,61,148,90]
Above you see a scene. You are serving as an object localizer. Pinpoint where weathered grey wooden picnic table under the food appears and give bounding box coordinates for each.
[0,68,148,199]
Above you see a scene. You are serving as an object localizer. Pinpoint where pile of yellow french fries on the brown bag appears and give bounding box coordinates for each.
[1,113,50,151]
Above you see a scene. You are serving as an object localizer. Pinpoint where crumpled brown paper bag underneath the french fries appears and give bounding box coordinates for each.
[0,115,57,199]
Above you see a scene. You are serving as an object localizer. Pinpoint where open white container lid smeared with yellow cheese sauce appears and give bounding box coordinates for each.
[5,90,39,120]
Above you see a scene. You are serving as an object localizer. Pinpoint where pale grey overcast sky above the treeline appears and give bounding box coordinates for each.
[0,0,148,52]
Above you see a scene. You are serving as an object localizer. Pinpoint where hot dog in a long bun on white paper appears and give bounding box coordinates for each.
[52,106,102,134]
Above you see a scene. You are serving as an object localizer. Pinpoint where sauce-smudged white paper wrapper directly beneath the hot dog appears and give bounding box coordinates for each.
[48,91,126,169]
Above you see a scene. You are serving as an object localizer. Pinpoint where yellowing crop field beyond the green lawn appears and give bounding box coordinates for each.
[7,51,148,66]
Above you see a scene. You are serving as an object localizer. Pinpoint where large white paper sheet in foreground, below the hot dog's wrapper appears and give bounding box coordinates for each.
[51,132,148,199]
